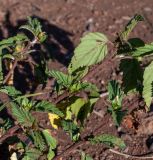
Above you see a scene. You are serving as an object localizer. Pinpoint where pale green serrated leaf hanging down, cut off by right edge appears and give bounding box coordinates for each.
[143,62,153,108]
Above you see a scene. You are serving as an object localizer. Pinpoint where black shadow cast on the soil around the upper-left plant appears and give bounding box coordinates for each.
[0,12,74,93]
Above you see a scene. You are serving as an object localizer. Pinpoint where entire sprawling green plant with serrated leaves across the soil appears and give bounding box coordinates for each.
[0,15,153,160]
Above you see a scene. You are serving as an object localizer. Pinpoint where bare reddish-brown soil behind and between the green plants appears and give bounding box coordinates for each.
[0,0,153,160]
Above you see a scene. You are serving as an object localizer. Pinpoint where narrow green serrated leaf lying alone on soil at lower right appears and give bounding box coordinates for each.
[89,134,126,149]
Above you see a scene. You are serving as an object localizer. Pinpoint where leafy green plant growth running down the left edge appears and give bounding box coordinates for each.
[0,17,57,160]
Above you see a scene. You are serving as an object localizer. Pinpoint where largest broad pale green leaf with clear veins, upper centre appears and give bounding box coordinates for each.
[68,32,108,73]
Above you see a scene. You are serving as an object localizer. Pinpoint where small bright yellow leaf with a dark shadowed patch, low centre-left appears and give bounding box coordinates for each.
[48,113,60,129]
